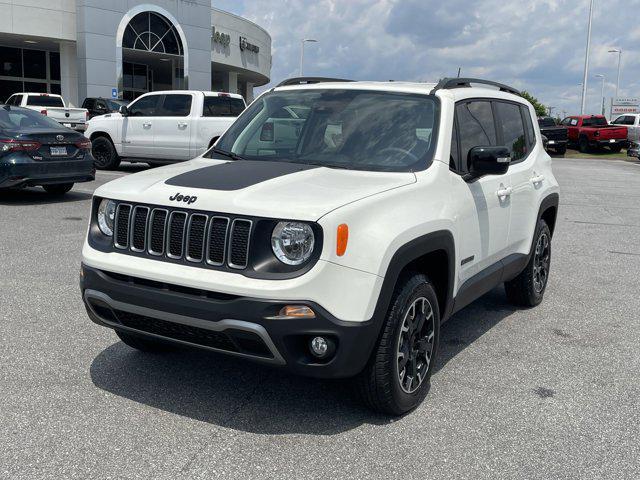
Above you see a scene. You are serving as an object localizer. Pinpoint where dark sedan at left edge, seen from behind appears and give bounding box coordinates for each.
[0,105,95,195]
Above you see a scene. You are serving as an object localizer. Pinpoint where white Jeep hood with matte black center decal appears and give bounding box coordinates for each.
[95,158,416,221]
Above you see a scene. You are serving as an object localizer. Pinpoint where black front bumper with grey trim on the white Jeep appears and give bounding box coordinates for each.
[80,265,381,378]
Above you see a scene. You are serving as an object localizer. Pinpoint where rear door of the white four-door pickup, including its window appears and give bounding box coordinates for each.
[153,93,194,160]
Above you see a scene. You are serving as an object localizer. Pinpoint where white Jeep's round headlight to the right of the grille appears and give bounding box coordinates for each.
[271,222,315,265]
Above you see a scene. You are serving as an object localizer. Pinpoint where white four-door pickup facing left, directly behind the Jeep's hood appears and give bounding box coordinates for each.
[85,90,246,170]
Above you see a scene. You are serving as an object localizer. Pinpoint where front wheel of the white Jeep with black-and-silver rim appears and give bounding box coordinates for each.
[357,274,440,415]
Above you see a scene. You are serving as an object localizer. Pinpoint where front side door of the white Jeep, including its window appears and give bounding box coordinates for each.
[452,99,511,283]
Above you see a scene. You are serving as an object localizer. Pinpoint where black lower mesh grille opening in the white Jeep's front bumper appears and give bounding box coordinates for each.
[114,310,238,352]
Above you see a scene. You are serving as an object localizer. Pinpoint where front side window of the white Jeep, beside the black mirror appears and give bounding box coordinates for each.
[456,100,497,173]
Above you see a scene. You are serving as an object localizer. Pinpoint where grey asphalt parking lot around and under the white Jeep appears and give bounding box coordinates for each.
[0,159,640,480]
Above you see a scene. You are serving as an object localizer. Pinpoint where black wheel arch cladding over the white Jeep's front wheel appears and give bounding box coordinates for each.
[375,230,455,324]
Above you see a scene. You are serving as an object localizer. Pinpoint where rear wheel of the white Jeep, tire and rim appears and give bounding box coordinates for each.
[504,220,551,307]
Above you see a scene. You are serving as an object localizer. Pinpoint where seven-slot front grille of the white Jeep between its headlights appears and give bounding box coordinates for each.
[113,203,253,270]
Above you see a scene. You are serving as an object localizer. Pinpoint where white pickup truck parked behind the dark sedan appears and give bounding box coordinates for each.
[6,92,89,132]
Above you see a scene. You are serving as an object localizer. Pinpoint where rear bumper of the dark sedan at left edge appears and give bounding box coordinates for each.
[0,155,96,188]
